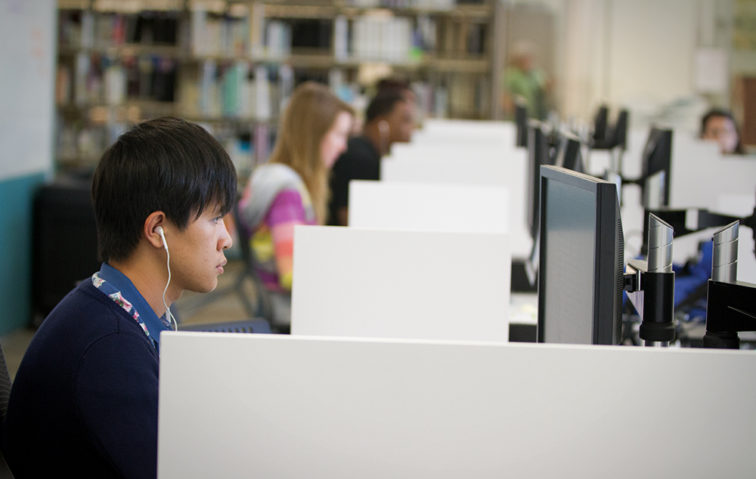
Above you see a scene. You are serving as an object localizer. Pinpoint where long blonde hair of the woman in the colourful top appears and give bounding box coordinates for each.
[270,82,354,224]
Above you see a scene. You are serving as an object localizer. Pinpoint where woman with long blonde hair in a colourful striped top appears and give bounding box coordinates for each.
[239,82,354,330]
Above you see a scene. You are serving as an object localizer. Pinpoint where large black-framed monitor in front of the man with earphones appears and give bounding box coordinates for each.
[538,166,624,344]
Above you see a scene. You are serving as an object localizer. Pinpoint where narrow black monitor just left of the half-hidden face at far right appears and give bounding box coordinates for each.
[641,128,672,209]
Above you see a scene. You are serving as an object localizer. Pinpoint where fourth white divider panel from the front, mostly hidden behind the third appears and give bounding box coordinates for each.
[381,149,533,257]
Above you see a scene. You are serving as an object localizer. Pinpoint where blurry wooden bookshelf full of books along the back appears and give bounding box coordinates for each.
[56,0,499,172]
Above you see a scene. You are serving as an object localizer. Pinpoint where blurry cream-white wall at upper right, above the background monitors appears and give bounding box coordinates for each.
[555,0,726,126]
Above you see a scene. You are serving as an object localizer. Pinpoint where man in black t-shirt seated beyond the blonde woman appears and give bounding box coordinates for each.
[328,89,415,226]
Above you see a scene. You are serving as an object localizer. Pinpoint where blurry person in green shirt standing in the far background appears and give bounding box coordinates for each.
[502,42,548,120]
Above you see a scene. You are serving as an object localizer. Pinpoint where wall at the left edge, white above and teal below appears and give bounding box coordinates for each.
[0,0,56,333]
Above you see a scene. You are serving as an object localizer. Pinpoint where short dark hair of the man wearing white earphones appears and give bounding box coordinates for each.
[92,117,237,261]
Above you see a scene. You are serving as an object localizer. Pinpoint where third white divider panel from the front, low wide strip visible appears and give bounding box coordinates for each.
[349,180,510,233]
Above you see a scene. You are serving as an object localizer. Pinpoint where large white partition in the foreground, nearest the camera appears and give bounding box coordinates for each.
[158,332,756,479]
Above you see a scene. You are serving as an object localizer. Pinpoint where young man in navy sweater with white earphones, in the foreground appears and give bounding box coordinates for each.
[4,118,236,478]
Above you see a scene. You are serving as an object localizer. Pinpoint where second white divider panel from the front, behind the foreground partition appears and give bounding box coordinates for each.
[291,226,511,341]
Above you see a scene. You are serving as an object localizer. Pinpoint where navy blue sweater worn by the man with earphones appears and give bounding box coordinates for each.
[5,280,158,479]
